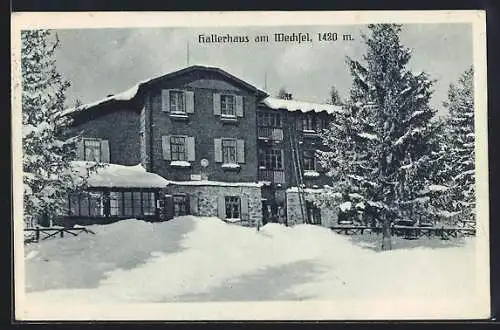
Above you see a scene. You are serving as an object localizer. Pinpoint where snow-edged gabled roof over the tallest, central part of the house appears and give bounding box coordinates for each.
[62,65,268,116]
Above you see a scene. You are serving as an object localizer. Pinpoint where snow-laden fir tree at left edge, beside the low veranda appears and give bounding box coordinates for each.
[21,30,82,226]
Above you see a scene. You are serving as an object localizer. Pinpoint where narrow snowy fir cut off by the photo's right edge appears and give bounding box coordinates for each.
[446,67,476,227]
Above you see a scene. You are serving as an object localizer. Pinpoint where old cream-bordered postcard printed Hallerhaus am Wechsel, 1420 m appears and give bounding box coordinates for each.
[11,11,490,321]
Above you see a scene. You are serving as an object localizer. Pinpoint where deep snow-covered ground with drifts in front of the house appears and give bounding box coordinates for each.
[20,216,488,318]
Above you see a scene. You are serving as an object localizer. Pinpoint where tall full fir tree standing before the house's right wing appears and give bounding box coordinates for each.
[319,24,439,250]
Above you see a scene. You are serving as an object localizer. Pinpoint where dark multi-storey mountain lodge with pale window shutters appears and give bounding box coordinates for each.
[61,66,341,226]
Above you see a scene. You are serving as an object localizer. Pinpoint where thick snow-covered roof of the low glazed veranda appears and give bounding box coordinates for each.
[72,161,169,188]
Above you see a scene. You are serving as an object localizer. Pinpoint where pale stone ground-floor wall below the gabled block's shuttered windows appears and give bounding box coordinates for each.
[167,185,262,227]
